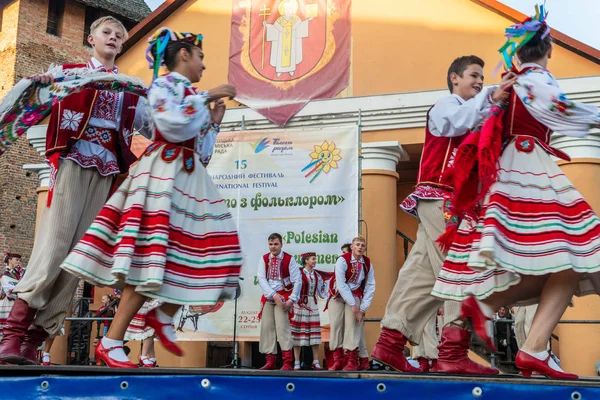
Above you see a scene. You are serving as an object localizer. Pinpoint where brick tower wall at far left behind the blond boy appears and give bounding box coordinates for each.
[0,0,90,264]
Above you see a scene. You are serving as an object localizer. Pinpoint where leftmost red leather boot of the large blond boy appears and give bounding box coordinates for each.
[0,298,37,365]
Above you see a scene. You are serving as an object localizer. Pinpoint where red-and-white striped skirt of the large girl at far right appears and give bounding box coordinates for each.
[432,140,600,301]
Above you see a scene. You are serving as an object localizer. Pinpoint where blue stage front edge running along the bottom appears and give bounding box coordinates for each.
[0,366,600,400]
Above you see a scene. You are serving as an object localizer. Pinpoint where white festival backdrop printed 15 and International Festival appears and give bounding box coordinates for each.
[175,126,359,340]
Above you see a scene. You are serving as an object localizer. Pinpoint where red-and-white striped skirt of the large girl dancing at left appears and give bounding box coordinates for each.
[61,146,242,305]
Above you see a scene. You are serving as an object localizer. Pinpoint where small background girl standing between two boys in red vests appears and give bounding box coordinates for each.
[291,253,332,371]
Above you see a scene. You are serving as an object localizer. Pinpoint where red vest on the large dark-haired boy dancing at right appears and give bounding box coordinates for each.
[417,104,469,190]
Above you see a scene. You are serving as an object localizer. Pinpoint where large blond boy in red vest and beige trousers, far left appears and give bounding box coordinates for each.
[0,17,146,364]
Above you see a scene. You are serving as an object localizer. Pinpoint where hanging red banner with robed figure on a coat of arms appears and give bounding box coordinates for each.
[229,0,351,126]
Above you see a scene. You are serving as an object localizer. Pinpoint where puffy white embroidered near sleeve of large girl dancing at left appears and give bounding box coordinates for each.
[148,75,210,142]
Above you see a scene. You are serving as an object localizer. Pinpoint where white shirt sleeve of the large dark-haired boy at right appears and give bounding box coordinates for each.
[428,87,496,137]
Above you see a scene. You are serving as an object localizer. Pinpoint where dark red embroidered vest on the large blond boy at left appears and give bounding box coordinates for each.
[46,64,139,173]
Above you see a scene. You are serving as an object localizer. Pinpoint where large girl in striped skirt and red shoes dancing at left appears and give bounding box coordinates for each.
[61,28,242,368]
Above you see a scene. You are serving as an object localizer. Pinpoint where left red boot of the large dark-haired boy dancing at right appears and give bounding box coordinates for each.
[372,328,423,372]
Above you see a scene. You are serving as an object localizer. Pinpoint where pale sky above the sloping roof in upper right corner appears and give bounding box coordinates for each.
[499,0,600,50]
